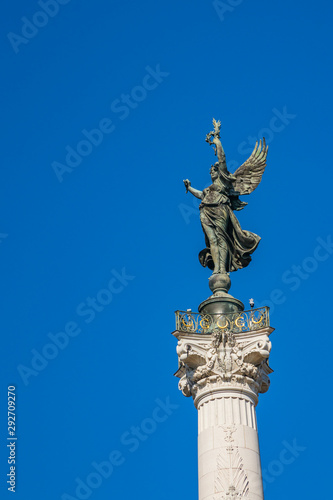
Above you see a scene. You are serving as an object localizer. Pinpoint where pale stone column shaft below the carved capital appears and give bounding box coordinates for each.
[197,388,264,500]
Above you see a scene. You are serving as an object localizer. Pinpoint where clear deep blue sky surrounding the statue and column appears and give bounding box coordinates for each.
[0,0,333,500]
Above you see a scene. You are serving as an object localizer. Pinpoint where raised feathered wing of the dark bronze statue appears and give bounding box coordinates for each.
[233,138,268,194]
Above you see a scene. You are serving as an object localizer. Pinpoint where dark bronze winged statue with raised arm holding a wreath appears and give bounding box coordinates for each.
[184,119,268,275]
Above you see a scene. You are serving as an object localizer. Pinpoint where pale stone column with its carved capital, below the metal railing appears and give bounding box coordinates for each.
[174,327,273,500]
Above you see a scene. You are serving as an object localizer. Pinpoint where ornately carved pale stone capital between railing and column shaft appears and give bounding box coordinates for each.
[174,327,273,398]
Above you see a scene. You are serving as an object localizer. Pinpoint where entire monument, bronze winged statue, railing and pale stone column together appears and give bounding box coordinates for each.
[174,119,273,500]
